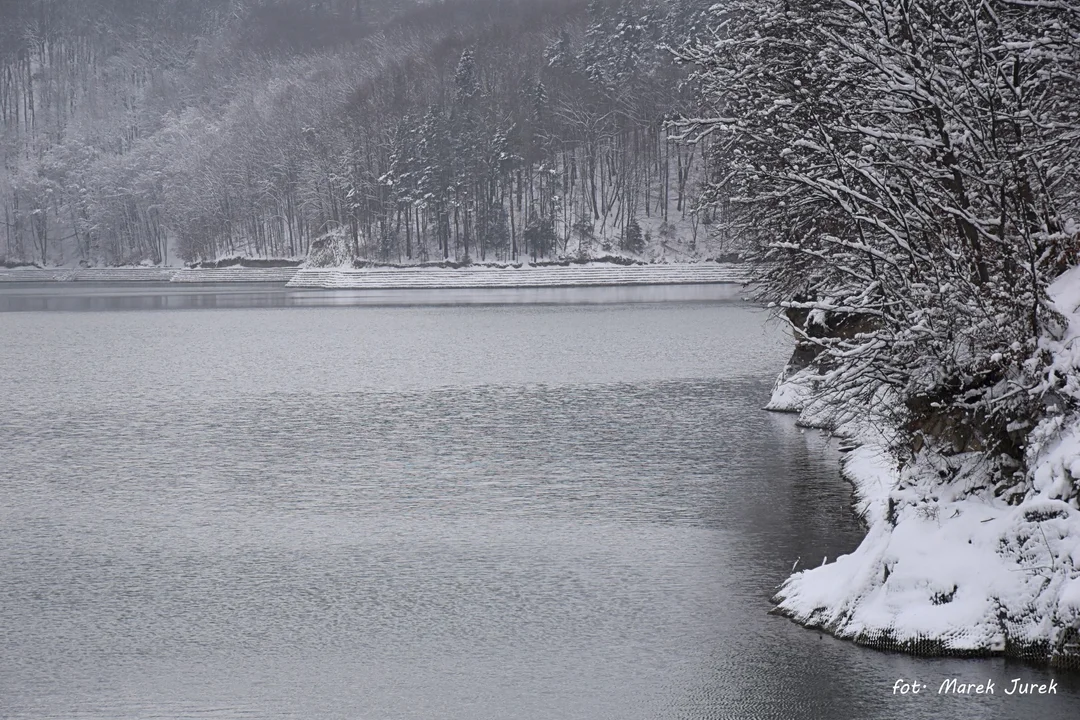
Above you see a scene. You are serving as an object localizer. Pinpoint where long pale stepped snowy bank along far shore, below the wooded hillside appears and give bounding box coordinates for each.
[288,262,745,289]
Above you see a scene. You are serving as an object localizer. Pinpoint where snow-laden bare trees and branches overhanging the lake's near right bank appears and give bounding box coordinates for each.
[685,0,1080,477]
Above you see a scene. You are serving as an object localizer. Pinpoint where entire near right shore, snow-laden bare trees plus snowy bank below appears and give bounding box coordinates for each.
[685,0,1080,664]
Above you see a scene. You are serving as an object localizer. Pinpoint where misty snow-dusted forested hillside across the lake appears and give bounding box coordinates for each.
[0,0,725,264]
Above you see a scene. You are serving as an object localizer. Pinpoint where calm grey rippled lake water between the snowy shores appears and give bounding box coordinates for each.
[0,285,1080,720]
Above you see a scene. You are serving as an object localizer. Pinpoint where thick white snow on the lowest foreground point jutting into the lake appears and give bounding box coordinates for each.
[779,446,1080,654]
